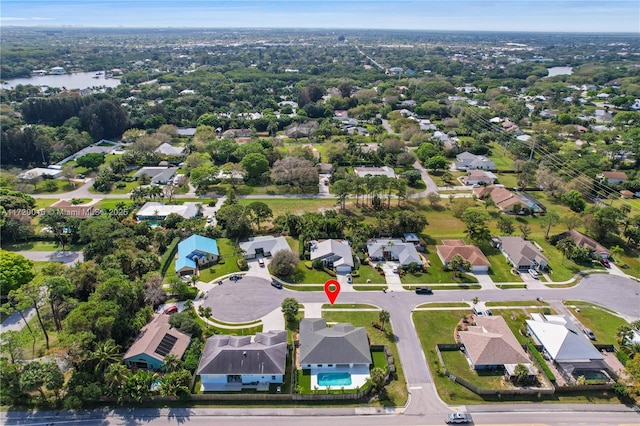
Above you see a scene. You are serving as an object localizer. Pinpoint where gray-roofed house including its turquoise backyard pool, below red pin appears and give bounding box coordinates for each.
[297,318,372,389]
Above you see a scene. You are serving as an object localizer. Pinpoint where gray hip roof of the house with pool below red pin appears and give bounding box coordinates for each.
[298,318,371,369]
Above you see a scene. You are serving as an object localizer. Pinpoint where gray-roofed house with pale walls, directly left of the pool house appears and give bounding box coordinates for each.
[196,331,287,391]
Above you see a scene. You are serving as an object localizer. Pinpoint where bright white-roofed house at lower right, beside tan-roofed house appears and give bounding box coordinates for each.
[526,313,609,378]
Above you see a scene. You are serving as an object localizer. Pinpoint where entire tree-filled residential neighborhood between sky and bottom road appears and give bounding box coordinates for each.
[0,27,640,423]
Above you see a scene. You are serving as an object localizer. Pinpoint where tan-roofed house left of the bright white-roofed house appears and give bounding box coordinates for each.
[458,315,536,376]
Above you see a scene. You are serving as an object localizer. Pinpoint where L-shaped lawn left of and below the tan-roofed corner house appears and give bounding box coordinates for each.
[413,310,621,405]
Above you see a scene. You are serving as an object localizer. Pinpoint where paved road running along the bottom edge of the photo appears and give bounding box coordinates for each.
[0,404,640,426]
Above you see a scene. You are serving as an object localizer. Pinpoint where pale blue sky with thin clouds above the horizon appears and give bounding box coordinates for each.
[0,0,640,34]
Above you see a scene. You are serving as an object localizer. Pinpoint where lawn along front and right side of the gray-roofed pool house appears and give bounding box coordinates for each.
[322,311,409,407]
